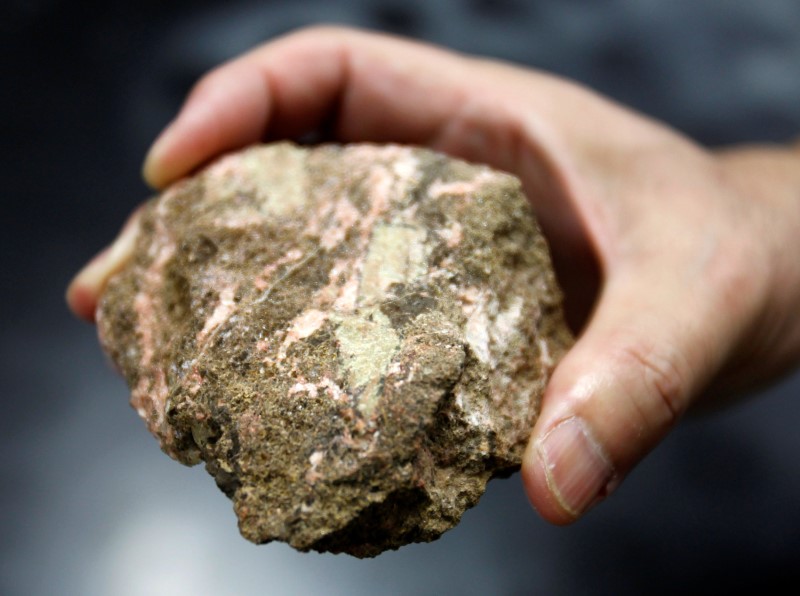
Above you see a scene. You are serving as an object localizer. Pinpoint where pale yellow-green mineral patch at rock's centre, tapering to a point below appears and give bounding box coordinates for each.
[336,309,400,416]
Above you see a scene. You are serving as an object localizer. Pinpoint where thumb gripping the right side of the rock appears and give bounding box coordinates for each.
[522,267,731,524]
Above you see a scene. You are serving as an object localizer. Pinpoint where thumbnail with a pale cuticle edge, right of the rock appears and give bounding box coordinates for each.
[539,417,614,518]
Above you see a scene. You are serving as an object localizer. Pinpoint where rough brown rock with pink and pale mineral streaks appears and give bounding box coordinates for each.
[98,143,571,557]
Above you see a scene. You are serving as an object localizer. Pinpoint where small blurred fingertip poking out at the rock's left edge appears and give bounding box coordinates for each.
[66,208,141,323]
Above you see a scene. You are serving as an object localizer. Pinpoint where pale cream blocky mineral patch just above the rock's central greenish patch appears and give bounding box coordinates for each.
[359,224,429,306]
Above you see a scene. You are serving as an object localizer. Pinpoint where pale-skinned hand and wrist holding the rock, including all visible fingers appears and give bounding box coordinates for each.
[67,28,800,524]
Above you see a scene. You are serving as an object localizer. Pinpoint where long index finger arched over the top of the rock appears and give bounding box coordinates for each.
[144,28,568,187]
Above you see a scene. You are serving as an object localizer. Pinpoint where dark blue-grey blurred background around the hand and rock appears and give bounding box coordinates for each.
[0,0,800,595]
